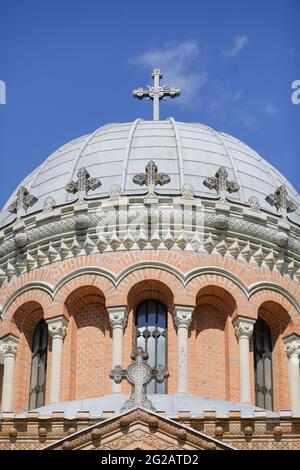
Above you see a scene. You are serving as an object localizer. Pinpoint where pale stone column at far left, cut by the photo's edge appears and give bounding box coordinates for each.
[0,335,19,412]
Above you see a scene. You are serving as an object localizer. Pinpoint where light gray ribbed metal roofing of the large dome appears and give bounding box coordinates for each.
[0,118,300,226]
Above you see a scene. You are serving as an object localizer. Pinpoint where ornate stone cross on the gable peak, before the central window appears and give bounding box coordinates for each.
[109,347,169,412]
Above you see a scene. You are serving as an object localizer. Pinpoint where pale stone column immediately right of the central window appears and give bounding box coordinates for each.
[174,305,194,393]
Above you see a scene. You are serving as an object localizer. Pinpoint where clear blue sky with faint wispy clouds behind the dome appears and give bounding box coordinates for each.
[0,0,300,206]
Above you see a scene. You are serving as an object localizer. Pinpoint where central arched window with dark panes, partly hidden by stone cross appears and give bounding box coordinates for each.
[136,299,167,394]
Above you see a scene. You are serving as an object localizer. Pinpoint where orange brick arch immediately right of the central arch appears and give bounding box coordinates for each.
[186,274,248,317]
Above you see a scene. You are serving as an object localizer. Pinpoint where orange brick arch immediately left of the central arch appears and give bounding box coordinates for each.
[47,273,116,318]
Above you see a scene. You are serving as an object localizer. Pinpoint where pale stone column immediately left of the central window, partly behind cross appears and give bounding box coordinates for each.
[107,306,128,393]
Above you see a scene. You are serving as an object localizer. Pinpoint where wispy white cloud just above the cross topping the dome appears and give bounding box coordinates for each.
[130,40,208,104]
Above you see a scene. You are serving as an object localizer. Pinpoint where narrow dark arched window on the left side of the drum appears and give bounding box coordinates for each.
[28,320,48,410]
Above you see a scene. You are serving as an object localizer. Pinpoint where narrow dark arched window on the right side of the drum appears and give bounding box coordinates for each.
[253,318,273,410]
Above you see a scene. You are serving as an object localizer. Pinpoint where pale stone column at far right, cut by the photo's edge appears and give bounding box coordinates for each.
[284,334,300,416]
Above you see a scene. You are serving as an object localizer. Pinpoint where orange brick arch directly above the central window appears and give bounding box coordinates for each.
[112,267,186,305]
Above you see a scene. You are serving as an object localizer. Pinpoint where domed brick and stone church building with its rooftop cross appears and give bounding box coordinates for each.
[0,71,300,450]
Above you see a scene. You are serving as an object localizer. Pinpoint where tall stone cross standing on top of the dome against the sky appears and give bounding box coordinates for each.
[132,69,180,121]
